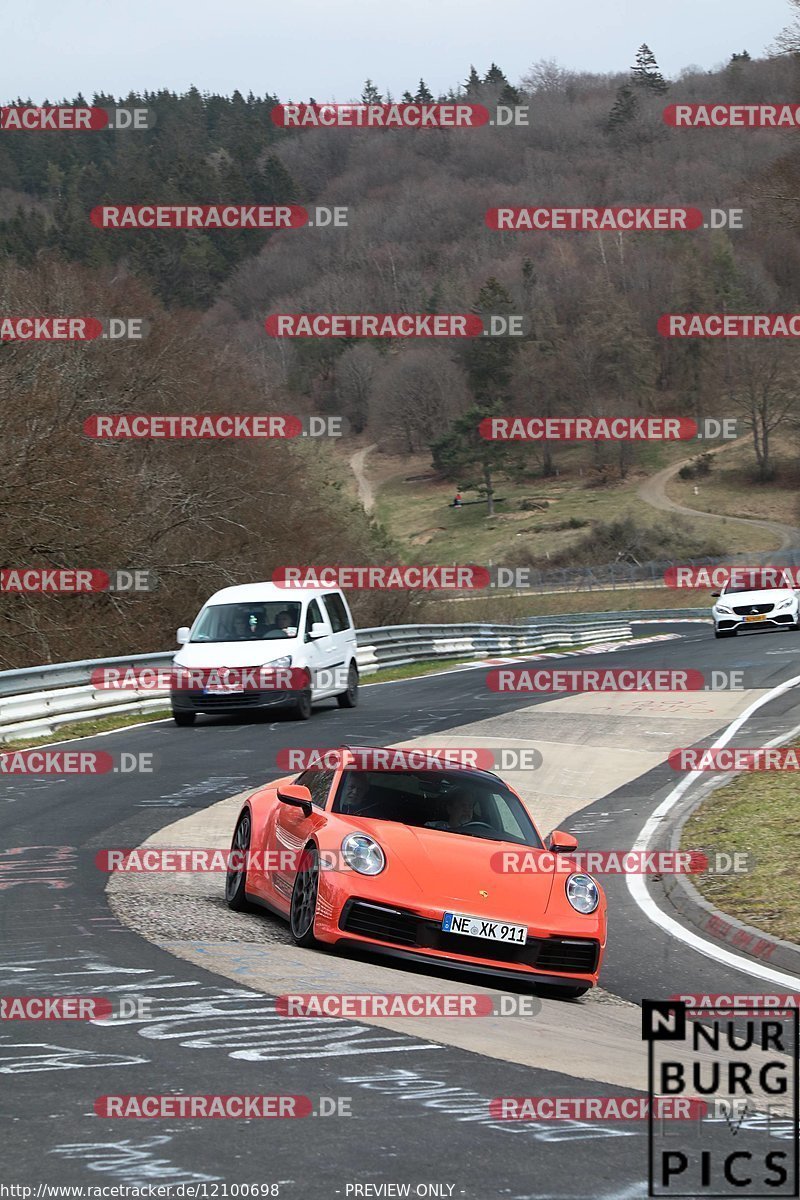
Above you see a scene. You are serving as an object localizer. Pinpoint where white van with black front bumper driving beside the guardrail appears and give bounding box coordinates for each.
[170,583,359,725]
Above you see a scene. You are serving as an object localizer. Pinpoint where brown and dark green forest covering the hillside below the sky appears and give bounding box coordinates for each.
[0,37,800,666]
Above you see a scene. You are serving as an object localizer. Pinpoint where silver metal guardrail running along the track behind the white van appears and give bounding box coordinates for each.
[0,608,703,743]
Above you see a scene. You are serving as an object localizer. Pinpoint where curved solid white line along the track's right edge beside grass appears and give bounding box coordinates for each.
[625,676,800,991]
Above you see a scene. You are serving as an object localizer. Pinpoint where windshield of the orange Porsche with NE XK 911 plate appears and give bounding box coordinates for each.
[332,770,543,852]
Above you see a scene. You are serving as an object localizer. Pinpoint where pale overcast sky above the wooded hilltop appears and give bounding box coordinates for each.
[0,0,790,103]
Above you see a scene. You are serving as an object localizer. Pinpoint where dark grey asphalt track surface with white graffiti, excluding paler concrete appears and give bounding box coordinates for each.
[0,624,800,1200]
